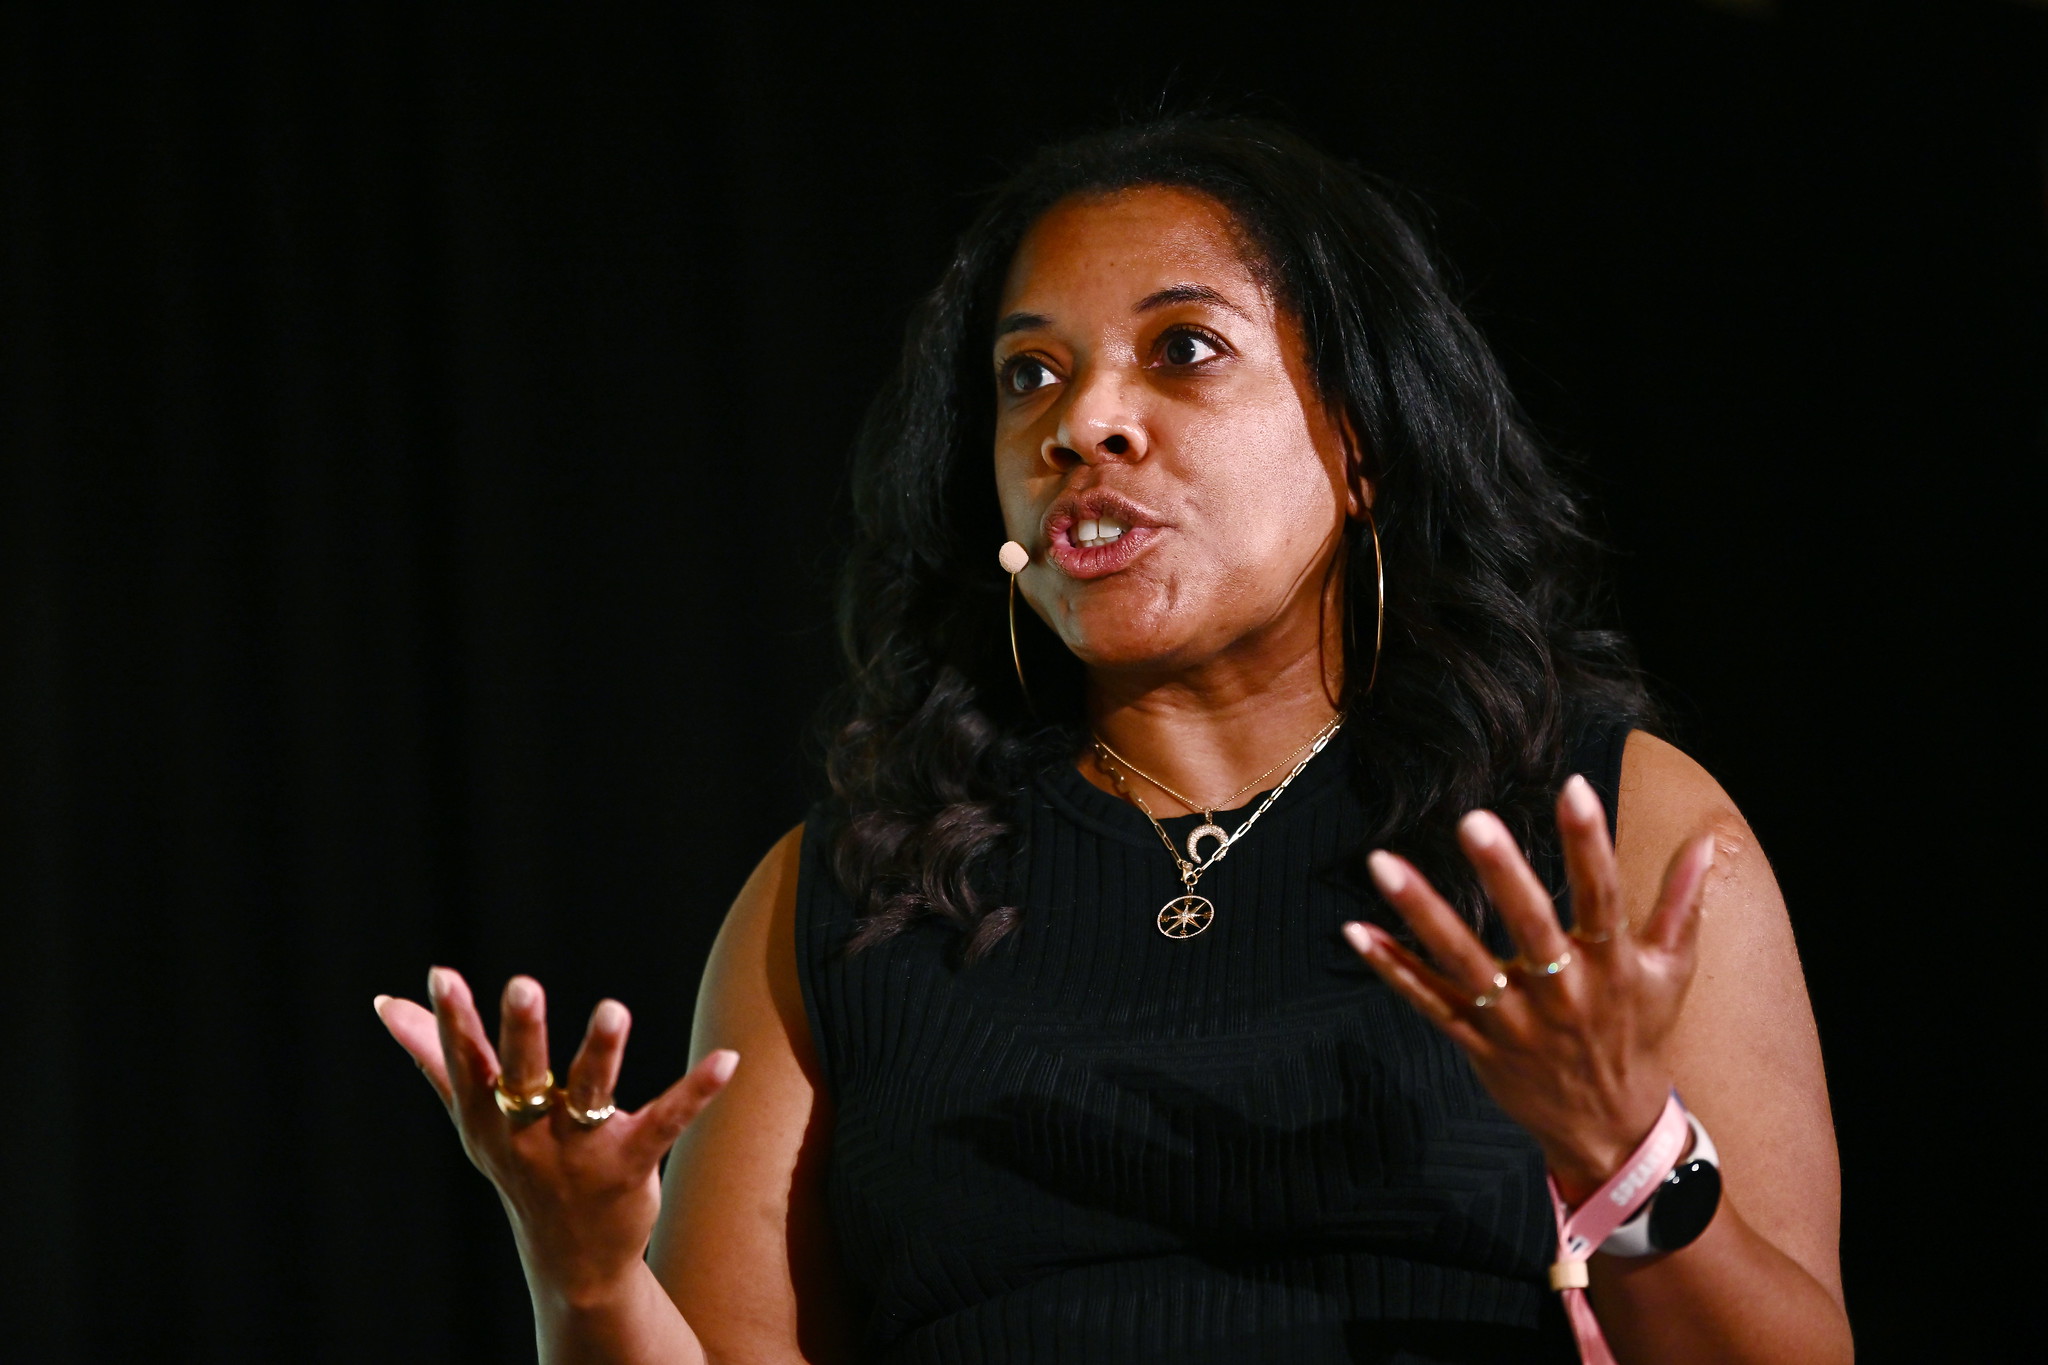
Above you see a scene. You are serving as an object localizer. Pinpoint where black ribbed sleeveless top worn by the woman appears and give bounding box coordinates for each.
[797,726,1626,1365]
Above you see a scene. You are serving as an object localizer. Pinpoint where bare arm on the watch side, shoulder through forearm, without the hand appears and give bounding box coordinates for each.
[1591,733,1851,1363]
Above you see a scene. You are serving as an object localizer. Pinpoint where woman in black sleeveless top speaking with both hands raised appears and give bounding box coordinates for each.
[377,121,1849,1365]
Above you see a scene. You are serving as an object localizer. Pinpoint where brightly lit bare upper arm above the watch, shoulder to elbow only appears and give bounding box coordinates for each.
[1614,731,1841,1302]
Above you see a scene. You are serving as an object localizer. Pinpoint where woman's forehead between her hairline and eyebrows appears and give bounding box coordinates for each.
[999,186,1268,313]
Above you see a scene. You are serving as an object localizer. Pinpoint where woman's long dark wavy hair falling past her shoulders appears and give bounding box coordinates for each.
[827,117,1653,962]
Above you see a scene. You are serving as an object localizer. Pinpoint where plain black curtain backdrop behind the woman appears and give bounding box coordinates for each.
[0,0,2048,1361]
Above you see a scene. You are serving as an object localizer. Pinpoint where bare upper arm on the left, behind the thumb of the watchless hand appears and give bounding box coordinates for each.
[649,825,844,1361]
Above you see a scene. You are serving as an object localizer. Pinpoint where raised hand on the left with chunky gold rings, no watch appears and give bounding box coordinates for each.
[377,966,739,1304]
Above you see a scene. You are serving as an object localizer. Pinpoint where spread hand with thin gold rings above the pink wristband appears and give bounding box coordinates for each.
[1346,778,1714,1205]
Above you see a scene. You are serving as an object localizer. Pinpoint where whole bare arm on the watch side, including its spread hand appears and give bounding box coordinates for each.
[1350,735,1853,1365]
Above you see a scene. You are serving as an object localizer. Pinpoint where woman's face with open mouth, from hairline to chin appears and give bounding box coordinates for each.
[995,188,1360,673]
